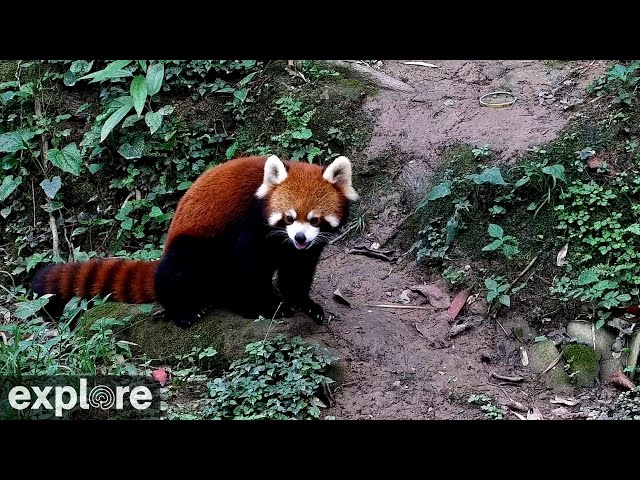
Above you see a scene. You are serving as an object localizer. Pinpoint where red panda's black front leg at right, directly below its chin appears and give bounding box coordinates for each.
[278,247,325,325]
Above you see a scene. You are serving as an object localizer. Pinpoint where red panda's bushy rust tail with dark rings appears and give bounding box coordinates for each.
[31,258,159,305]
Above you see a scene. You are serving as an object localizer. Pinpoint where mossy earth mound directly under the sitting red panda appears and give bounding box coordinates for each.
[77,302,335,372]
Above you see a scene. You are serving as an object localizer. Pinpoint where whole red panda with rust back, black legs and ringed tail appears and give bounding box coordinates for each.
[31,155,358,327]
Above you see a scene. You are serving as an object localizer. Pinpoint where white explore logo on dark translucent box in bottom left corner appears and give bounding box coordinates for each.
[0,376,160,419]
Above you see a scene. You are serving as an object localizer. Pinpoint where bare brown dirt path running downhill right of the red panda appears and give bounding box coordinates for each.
[314,60,605,419]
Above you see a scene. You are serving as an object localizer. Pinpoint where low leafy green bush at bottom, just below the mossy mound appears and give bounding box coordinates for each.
[205,336,333,419]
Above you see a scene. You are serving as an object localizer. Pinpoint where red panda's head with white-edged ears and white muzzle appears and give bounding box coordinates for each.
[256,155,358,250]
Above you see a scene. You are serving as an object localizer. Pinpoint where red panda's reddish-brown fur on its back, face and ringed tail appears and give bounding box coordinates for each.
[31,157,347,303]
